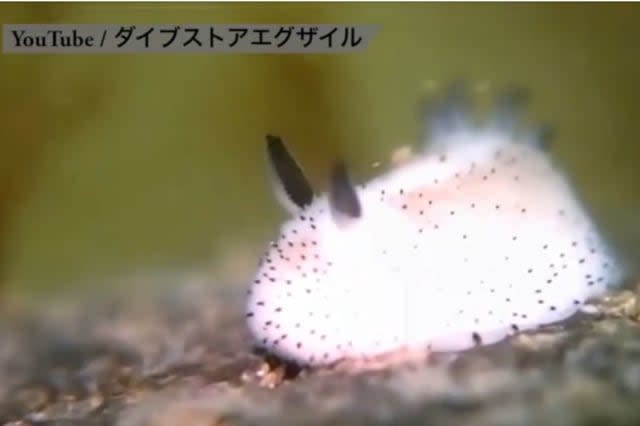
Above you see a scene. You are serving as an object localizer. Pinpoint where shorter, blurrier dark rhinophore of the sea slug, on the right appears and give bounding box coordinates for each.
[329,162,362,227]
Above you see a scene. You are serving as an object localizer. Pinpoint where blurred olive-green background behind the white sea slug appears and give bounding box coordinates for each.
[0,3,640,294]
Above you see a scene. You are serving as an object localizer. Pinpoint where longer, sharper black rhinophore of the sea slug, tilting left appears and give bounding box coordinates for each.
[267,135,313,213]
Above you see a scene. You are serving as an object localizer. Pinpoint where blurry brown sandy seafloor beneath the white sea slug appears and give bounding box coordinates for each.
[0,273,640,426]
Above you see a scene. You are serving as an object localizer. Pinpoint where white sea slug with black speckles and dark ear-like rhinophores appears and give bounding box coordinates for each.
[246,85,622,366]
